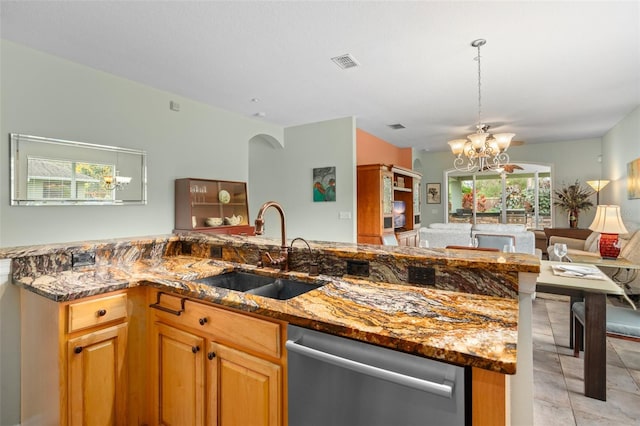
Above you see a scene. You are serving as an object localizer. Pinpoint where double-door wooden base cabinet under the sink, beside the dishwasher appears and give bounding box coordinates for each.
[149,290,285,426]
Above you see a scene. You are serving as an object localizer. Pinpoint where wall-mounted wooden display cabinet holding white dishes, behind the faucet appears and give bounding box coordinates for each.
[174,178,255,235]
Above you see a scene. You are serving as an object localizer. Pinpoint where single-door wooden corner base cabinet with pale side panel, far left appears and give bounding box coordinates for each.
[21,290,131,425]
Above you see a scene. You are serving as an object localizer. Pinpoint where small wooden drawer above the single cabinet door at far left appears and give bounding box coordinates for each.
[68,294,127,333]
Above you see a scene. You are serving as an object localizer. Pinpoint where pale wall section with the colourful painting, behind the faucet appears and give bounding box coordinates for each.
[249,117,357,242]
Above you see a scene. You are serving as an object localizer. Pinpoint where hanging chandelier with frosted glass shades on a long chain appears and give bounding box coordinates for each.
[447,39,515,172]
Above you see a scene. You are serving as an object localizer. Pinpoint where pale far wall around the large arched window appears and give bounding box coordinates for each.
[415,138,608,228]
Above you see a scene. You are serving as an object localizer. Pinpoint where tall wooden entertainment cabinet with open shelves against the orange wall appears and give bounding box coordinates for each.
[357,164,421,245]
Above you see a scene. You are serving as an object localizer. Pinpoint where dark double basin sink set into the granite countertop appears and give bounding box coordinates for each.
[194,271,324,300]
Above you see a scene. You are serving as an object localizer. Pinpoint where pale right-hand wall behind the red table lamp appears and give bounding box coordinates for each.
[600,106,640,229]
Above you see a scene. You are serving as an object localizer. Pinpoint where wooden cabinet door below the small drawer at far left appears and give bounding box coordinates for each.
[67,323,127,426]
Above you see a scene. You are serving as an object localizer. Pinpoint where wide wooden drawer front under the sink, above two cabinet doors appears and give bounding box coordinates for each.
[155,294,282,358]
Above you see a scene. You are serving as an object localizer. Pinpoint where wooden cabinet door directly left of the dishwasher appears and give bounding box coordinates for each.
[208,342,282,426]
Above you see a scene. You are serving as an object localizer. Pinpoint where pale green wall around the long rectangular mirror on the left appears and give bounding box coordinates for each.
[0,40,284,247]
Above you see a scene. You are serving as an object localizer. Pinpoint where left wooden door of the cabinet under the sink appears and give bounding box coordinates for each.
[152,323,205,426]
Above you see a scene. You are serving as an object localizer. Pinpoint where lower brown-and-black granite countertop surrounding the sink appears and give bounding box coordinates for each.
[14,255,516,374]
